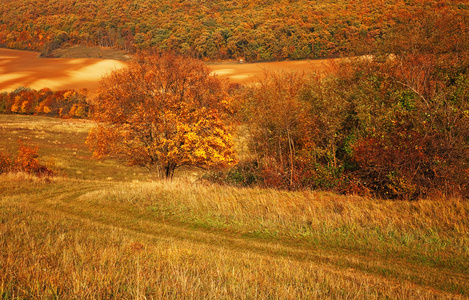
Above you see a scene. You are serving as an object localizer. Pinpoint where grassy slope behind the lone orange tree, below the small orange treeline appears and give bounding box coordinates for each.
[0,115,148,181]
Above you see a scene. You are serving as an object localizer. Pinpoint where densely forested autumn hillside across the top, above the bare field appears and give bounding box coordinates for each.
[0,0,469,61]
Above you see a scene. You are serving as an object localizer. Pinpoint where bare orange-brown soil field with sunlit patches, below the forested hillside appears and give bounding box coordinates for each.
[0,49,328,92]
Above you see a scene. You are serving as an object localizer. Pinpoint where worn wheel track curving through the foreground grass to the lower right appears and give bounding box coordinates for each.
[19,185,469,297]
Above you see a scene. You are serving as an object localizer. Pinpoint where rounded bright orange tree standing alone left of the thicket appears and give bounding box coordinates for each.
[88,54,234,178]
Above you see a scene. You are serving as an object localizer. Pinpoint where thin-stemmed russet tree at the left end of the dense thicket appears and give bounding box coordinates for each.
[242,73,314,188]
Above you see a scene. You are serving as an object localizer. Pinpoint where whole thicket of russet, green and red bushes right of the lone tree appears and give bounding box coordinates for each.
[217,53,469,199]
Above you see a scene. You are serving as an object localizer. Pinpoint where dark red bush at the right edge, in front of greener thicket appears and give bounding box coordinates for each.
[353,116,468,199]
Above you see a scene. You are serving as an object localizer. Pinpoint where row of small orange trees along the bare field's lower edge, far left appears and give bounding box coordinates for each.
[0,87,90,118]
